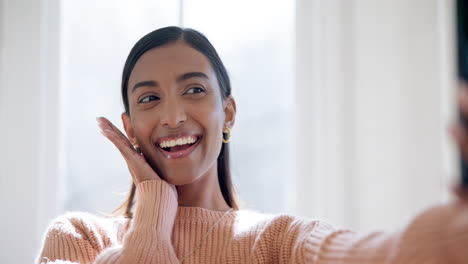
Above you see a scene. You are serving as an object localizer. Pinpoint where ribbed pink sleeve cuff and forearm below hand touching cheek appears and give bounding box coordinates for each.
[95,180,178,264]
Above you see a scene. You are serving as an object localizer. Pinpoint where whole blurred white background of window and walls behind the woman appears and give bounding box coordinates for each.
[0,0,459,263]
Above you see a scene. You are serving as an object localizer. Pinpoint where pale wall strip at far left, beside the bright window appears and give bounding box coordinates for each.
[0,0,59,263]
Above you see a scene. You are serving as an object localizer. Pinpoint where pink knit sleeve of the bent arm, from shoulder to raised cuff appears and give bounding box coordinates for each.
[36,180,178,264]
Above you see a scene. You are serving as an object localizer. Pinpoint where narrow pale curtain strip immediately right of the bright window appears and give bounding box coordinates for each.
[296,0,354,229]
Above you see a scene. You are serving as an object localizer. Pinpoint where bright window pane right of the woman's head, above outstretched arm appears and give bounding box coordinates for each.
[183,0,295,213]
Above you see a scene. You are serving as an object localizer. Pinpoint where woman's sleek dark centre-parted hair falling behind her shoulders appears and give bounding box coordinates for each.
[114,26,239,217]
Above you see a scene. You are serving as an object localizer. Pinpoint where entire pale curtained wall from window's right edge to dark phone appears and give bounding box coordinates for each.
[296,0,457,231]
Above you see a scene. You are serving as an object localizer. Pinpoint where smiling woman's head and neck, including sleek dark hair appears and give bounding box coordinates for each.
[116,27,238,214]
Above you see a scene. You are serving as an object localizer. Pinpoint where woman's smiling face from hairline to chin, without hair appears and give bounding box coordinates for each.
[122,41,236,185]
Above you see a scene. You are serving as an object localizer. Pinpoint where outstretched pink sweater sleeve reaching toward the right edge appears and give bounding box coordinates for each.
[296,201,468,264]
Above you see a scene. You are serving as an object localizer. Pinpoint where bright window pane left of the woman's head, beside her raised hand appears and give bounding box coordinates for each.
[61,0,179,212]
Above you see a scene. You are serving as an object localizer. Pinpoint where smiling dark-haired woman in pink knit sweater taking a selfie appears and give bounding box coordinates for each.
[37,27,468,263]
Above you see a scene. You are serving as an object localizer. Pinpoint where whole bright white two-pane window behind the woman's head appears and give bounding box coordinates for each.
[61,0,294,212]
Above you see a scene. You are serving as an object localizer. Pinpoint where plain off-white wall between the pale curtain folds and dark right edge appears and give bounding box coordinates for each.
[352,0,455,229]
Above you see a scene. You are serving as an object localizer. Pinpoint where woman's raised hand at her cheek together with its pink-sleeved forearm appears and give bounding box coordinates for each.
[95,118,178,264]
